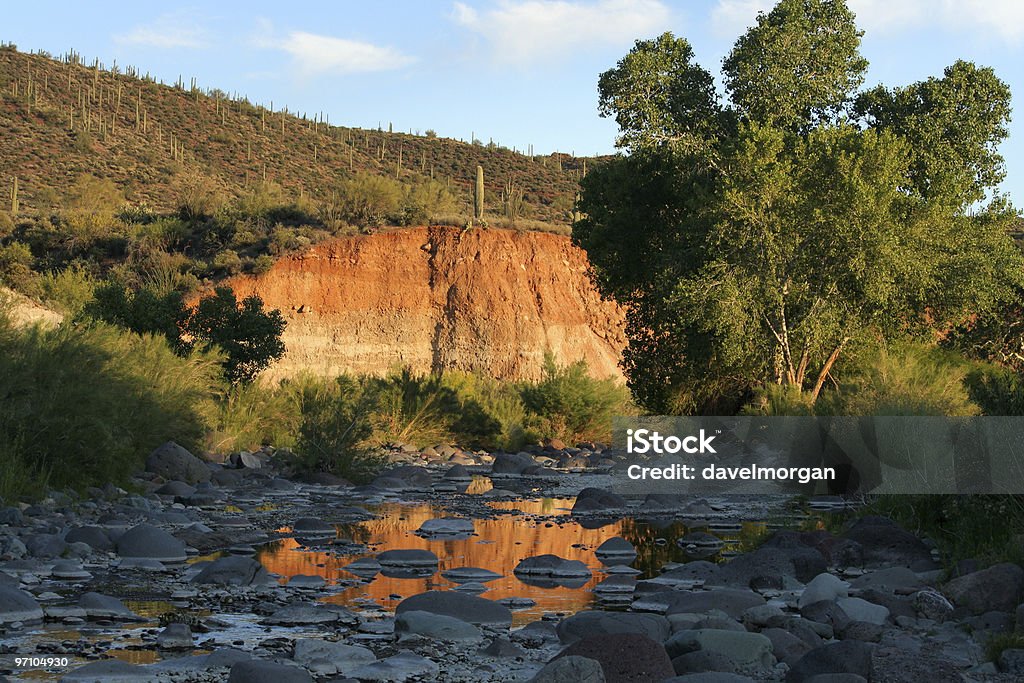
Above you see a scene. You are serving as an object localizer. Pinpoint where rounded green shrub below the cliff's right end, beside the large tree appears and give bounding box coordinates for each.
[522,353,633,441]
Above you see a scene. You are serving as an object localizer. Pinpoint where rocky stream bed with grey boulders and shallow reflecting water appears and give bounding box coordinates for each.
[0,444,1024,682]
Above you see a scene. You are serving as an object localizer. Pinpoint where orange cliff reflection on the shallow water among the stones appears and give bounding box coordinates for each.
[257,498,770,625]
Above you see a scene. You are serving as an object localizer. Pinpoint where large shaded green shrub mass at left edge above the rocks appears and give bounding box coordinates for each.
[0,315,220,498]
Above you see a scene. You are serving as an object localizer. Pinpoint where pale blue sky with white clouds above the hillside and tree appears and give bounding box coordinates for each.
[6,0,1024,206]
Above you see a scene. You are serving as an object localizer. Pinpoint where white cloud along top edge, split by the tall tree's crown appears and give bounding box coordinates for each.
[711,0,1024,43]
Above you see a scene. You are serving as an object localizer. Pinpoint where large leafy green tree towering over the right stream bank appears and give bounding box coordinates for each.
[573,0,1021,412]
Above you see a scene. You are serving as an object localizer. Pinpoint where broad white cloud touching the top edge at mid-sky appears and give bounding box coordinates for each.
[453,0,672,63]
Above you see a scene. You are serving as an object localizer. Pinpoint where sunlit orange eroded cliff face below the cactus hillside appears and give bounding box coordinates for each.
[223,227,626,379]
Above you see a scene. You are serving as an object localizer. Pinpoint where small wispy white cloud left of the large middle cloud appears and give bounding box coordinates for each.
[251,19,416,76]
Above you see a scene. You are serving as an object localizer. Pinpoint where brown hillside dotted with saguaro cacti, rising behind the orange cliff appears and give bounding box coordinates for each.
[0,46,593,223]
